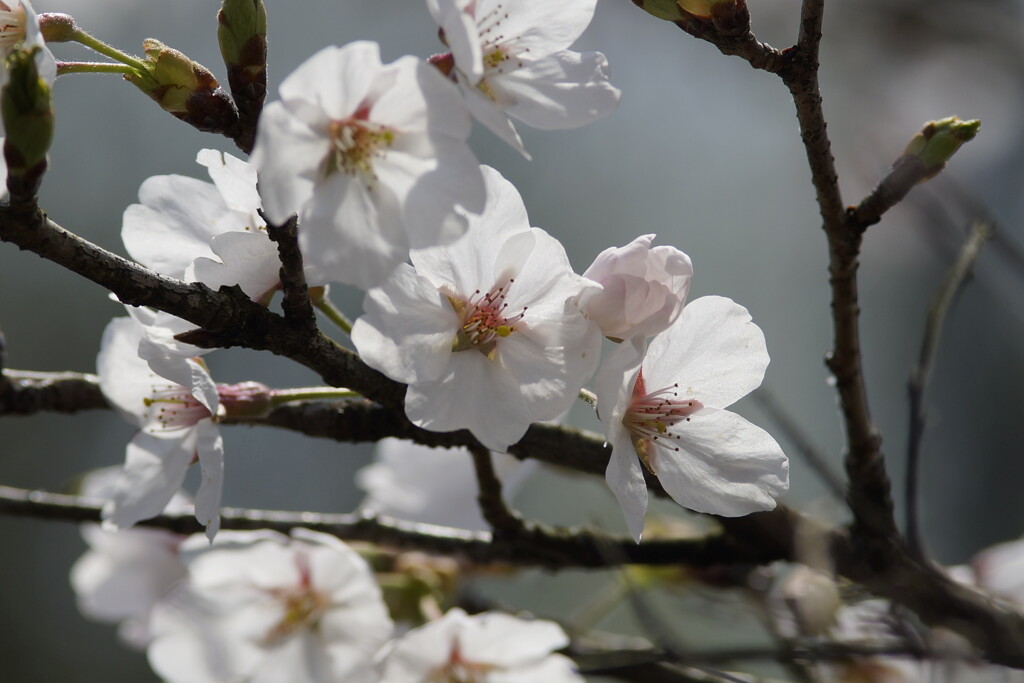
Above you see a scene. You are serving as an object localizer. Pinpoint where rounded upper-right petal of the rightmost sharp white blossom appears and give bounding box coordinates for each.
[644,297,768,408]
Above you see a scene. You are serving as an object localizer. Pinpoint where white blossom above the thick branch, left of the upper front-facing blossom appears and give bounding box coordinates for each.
[121,150,317,301]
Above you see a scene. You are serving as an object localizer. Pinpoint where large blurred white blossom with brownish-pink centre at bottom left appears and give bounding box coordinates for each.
[148,529,392,683]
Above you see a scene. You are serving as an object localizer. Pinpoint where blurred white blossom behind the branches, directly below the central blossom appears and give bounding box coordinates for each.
[355,438,534,530]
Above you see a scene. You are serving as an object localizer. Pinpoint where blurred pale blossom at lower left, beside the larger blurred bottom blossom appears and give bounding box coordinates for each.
[71,468,191,649]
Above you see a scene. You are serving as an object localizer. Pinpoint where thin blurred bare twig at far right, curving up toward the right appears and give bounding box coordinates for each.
[906,220,993,560]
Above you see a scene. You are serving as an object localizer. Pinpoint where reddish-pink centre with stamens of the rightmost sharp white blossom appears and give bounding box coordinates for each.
[623,368,703,471]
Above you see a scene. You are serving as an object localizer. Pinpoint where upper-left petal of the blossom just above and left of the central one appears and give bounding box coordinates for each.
[281,40,382,120]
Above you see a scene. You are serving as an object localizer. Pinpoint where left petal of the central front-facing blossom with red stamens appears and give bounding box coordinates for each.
[352,263,459,383]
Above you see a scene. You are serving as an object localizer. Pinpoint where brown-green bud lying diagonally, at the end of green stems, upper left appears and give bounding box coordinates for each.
[125,38,238,132]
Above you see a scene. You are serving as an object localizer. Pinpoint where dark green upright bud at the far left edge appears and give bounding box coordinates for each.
[0,47,53,196]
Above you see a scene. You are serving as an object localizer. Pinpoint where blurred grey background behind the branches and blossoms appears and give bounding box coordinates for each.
[0,0,1024,683]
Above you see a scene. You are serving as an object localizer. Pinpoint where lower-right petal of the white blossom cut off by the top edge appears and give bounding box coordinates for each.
[488,50,622,130]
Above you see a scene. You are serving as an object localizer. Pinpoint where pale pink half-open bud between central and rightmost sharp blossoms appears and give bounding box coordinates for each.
[578,234,693,341]
